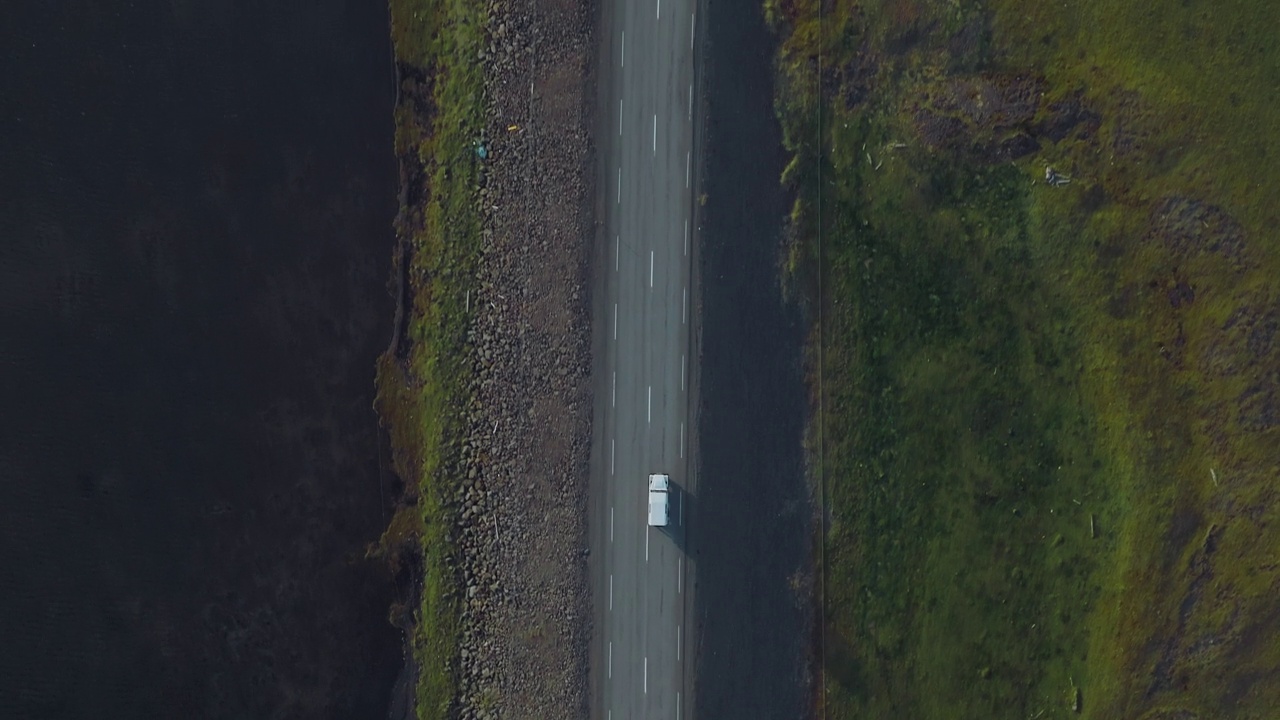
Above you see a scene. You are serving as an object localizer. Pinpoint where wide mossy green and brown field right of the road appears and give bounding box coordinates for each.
[764,0,1280,720]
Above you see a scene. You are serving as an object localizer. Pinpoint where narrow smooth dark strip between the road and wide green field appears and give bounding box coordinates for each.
[690,0,813,720]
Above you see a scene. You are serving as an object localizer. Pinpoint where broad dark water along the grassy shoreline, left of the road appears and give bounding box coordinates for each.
[0,0,399,719]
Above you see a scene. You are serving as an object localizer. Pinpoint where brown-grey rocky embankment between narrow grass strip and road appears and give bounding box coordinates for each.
[456,0,595,719]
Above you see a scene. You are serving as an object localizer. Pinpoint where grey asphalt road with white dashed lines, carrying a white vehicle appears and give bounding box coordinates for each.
[591,0,696,720]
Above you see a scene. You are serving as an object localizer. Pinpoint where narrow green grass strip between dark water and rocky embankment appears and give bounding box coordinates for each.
[372,0,486,720]
